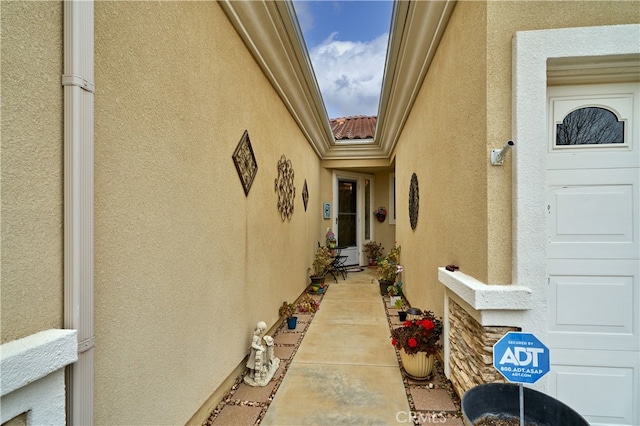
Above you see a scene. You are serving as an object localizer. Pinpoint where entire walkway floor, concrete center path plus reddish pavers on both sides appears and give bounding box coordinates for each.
[205,268,463,426]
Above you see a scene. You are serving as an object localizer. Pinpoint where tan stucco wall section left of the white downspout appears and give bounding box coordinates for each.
[0,1,64,343]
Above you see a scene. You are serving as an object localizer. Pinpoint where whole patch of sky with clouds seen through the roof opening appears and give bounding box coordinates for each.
[294,0,393,118]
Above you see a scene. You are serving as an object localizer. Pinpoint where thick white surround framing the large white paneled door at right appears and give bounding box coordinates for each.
[512,24,640,412]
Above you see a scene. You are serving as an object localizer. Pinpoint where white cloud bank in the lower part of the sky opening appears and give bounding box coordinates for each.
[309,33,388,118]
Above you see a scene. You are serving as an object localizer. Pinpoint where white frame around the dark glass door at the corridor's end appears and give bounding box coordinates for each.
[331,170,375,266]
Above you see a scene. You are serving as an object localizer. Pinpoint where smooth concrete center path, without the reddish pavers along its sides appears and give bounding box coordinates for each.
[261,272,410,425]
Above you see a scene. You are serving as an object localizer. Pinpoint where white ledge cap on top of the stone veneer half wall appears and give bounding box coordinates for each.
[438,268,533,311]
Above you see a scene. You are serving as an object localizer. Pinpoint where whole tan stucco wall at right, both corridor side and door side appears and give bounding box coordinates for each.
[396,1,640,314]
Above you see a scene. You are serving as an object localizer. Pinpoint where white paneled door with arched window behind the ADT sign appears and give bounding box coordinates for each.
[546,83,640,425]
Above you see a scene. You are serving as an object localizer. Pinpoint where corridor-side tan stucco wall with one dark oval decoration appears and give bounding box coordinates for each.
[396,2,487,315]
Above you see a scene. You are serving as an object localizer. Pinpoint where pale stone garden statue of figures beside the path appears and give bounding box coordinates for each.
[244,321,280,386]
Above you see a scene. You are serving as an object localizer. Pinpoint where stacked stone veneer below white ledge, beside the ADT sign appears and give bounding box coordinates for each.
[449,299,519,397]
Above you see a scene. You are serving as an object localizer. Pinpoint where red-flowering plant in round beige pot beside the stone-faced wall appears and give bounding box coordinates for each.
[391,311,442,380]
